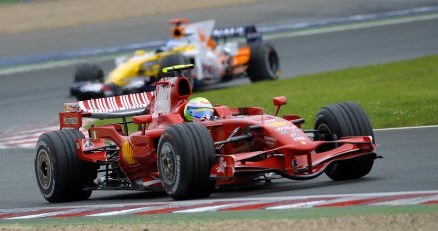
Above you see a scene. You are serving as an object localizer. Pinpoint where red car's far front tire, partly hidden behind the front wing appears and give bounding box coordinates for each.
[314,102,375,181]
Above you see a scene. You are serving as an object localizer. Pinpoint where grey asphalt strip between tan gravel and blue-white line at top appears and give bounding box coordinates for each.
[0,0,438,59]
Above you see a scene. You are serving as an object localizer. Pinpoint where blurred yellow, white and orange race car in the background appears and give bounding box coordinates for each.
[70,19,280,100]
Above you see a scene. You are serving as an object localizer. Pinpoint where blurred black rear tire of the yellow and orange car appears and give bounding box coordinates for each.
[247,42,280,82]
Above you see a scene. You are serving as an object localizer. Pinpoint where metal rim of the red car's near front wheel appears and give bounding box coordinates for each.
[159,142,176,185]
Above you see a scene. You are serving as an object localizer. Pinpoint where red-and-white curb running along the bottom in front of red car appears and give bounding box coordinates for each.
[0,190,438,220]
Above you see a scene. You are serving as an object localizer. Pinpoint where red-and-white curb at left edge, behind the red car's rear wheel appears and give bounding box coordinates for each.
[0,121,86,149]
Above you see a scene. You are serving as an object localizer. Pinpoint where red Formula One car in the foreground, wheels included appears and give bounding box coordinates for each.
[35,65,378,202]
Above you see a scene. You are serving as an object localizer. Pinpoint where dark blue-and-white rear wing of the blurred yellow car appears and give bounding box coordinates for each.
[211,25,262,43]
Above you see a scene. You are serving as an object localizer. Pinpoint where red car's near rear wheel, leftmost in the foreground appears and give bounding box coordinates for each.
[35,129,98,203]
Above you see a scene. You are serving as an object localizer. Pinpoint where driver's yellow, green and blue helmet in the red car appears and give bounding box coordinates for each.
[184,97,213,121]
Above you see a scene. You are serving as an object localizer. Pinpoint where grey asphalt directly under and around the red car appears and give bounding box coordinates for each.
[0,127,438,208]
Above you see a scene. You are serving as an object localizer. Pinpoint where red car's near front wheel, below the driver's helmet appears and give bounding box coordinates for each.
[157,123,215,200]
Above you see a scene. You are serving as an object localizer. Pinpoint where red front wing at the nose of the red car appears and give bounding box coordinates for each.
[210,136,377,180]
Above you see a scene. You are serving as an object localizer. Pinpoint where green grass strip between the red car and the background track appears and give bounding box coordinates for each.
[90,55,438,128]
